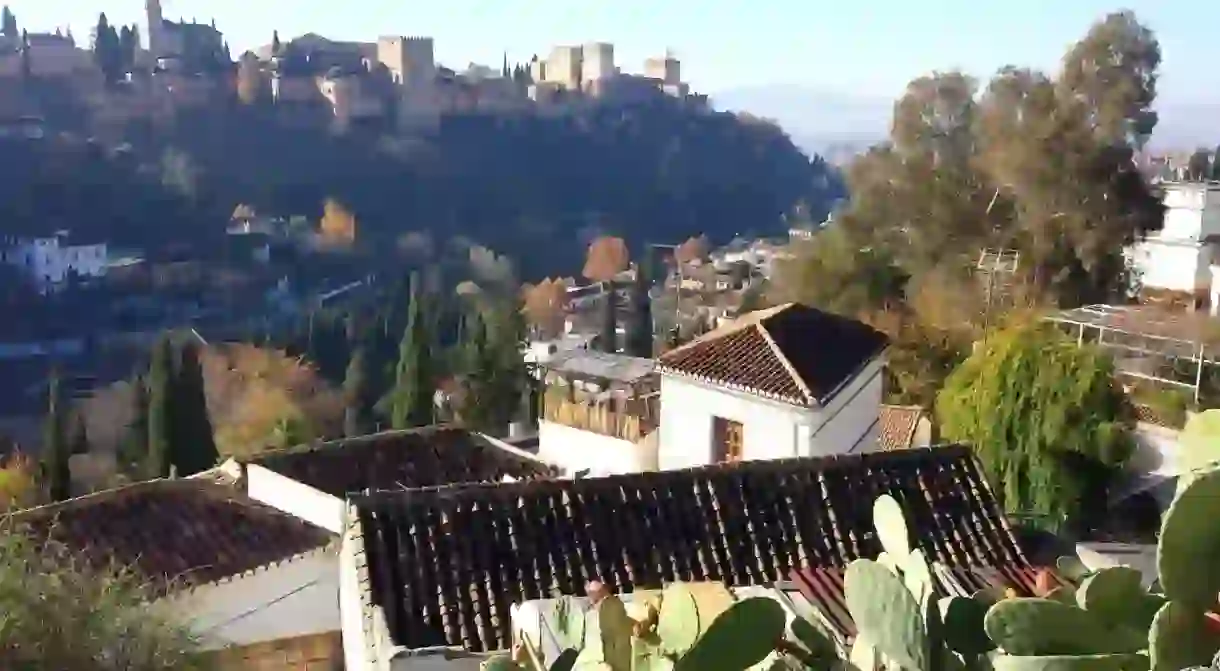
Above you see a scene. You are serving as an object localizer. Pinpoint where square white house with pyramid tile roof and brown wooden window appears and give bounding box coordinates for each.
[658,304,887,468]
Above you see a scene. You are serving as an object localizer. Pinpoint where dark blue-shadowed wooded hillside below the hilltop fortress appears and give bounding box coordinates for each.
[7,95,842,278]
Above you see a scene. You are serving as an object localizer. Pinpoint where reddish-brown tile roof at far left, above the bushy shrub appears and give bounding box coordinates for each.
[12,478,334,588]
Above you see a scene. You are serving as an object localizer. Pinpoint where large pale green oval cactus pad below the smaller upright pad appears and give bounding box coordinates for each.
[843,558,928,671]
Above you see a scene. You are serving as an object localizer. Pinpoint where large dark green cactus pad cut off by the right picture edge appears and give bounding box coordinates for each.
[1157,470,1220,609]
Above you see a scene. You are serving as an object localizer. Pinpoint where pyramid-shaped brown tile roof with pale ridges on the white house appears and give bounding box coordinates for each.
[658,303,888,406]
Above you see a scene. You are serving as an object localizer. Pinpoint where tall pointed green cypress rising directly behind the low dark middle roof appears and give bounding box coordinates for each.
[390,273,436,428]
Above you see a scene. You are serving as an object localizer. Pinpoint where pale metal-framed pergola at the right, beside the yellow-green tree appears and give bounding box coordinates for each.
[1046,305,1220,401]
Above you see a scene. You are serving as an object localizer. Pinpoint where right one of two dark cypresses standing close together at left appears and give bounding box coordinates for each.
[170,340,220,476]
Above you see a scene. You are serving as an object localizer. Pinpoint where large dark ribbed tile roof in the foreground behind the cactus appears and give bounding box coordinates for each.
[351,447,1025,651]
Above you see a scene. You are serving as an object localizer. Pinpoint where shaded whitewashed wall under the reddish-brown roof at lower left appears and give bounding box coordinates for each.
[157,549,340,650]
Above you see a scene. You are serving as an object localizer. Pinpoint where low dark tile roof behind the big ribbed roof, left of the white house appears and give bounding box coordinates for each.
[246,426,559,497]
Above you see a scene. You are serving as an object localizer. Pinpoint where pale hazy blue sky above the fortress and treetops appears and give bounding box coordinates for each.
[9,0,1220,101]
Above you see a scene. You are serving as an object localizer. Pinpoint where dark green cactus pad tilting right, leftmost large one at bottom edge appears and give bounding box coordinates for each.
[675,597,788,671]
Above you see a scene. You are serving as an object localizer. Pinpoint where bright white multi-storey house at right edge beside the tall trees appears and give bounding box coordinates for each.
[1129,183,1220,303]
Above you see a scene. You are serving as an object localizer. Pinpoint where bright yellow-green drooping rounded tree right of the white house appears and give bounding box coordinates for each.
[936,320,1133,528]
